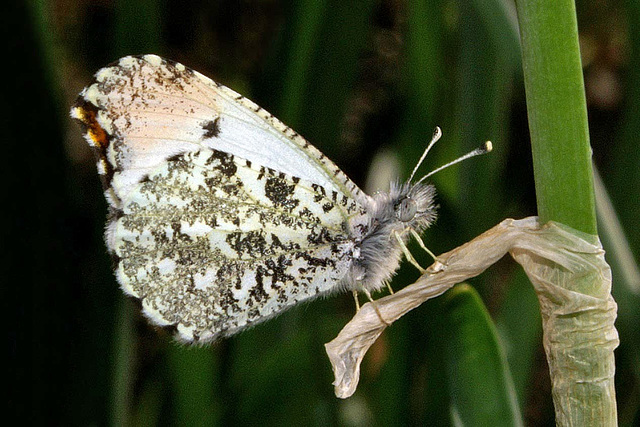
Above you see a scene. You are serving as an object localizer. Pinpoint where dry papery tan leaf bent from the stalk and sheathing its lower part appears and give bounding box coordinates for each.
[325,217,618,425]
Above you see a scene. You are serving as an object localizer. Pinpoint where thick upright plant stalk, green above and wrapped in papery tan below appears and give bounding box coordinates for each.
[516,0,617,426]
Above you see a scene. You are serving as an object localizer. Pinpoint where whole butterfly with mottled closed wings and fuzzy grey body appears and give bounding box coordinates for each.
[71,55,490,343]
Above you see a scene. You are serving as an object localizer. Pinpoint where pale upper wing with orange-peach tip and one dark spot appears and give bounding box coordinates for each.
[71,55,370,209]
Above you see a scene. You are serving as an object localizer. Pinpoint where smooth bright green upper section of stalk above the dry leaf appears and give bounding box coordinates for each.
[516,0,597,234]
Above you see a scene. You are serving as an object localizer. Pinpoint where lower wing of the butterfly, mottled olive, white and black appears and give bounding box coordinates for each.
[107,149,364,342]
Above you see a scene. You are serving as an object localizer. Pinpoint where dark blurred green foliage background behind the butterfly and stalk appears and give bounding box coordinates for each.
[6,0,640,426]
